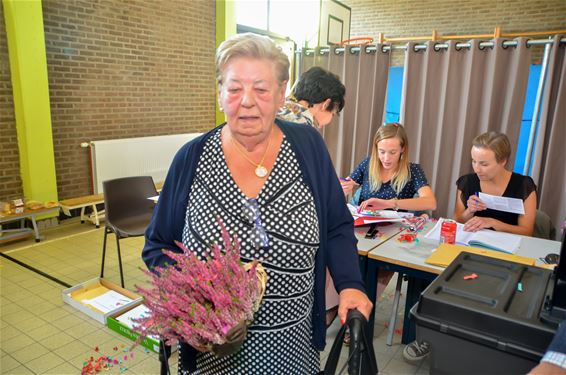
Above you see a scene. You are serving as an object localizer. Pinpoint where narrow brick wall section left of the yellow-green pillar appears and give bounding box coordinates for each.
[0,4,22,201]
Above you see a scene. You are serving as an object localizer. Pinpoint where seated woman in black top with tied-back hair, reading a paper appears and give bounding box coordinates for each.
[454,132,537,236]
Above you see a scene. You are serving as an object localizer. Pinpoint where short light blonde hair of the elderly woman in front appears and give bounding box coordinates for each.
[216,33,289,85]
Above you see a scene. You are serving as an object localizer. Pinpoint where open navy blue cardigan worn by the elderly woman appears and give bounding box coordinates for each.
[142,119,365,356]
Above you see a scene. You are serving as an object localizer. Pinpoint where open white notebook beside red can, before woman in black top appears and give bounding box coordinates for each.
[425,219,521,254]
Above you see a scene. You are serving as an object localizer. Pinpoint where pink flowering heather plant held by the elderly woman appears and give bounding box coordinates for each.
[137,222,266,351]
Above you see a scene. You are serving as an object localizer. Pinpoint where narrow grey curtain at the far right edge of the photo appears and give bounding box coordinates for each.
[532,35,566,233]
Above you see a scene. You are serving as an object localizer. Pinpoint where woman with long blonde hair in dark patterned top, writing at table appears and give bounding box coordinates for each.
[341,123,436,362]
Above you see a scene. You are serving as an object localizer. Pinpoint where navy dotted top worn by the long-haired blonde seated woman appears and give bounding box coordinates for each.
[350,157,428,204]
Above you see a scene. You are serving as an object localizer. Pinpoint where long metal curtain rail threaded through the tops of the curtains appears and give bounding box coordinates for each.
[295,38,566,56]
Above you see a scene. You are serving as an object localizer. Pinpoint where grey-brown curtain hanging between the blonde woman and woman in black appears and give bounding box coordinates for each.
[400,38,531,217]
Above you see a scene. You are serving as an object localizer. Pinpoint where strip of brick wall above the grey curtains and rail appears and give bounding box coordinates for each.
[343,0,566,66]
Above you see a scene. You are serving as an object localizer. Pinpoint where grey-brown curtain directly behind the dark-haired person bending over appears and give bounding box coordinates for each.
[298,45,390,176]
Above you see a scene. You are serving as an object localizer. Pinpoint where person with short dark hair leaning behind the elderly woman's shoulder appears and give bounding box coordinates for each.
[277,66,346,128]
